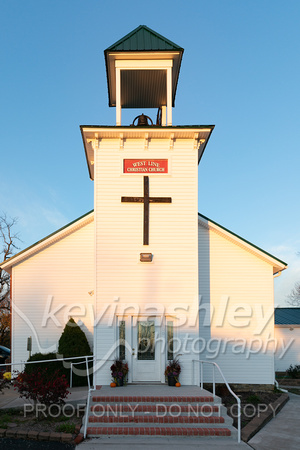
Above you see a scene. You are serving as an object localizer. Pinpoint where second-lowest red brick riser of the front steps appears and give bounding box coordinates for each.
[89,415,225,424]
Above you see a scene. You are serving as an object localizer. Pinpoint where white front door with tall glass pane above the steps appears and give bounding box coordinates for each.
[132,317,161,381]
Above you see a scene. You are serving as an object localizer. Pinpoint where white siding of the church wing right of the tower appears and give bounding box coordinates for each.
[199,221,274,384]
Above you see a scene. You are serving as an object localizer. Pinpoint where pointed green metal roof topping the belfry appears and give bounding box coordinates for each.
[105,25,183,52]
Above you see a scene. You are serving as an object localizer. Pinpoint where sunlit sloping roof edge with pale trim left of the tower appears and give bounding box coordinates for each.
[0,210,94,272]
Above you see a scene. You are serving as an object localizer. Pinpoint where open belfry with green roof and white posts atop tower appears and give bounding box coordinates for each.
[104,25,184,126]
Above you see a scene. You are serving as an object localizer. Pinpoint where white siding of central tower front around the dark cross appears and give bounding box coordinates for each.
[95,139,199,384]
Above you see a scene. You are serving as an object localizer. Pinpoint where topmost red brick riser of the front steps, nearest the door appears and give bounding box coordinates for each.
[92,395,214,403]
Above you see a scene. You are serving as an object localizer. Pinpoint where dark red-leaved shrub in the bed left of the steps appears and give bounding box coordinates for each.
[14,367,69,408]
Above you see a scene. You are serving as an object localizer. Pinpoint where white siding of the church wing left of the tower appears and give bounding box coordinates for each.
[12,222,94,368]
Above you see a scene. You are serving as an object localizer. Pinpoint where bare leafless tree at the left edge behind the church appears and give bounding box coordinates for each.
[0,213,20,347]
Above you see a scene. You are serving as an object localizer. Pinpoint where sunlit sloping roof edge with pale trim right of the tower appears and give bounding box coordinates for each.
[198,213,288,275]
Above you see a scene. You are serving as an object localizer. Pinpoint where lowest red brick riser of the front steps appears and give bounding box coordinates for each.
[87,426,231,437]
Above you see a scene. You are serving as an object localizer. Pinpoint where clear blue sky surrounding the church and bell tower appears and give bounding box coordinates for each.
[0,0,300,306]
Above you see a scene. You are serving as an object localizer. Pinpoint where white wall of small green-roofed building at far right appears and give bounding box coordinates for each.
[275,325,300,372]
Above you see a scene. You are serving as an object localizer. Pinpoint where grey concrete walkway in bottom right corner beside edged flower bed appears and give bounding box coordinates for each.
[249,393,300,450]
